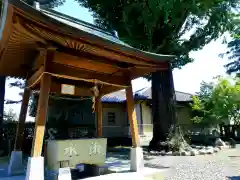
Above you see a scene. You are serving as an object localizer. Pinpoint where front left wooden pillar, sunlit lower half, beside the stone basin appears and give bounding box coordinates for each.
[31,74,51,157]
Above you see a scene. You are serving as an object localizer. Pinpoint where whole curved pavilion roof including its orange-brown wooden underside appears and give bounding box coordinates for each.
[0,0,174,95]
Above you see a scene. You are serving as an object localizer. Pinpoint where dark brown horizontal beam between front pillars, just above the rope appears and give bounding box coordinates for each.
[51,63,127,86]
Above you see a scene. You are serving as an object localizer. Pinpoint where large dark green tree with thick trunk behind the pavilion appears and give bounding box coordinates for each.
[76,0,240,147]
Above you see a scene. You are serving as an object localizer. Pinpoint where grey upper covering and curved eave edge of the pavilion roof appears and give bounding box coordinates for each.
[0,0,174,67]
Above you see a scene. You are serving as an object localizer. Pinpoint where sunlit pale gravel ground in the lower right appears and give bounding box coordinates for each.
[146,145,240,180]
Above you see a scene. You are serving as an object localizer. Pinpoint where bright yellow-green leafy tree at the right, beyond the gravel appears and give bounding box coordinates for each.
[192,77,240,125]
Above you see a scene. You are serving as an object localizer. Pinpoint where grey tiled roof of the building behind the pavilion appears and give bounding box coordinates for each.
[102,87,193,103]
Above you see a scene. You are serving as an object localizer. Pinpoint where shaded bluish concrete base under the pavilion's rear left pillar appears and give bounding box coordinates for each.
[8,151,24,176]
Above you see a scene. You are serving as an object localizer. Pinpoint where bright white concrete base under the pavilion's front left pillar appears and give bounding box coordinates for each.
[25,156,44,180]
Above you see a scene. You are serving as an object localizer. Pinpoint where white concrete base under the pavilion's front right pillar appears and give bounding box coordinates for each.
[130,147,144,172]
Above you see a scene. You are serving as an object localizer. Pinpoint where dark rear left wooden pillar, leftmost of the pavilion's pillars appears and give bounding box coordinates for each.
[14,88,31,151]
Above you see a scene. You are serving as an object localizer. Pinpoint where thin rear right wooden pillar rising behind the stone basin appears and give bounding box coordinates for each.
[96,96,103,137]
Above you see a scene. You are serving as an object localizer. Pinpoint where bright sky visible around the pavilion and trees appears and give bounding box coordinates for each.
[5,0,227,120]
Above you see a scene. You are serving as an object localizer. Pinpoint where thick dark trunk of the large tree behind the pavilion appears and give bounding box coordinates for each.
[149,64,176,150]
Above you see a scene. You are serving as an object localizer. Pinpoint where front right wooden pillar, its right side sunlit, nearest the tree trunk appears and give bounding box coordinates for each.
[126,86,140,147]
